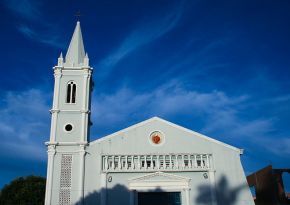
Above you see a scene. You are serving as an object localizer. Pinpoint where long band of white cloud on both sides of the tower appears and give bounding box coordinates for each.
[0,80,280,160]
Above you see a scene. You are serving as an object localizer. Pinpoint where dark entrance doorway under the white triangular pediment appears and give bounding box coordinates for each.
[138,192,181,205]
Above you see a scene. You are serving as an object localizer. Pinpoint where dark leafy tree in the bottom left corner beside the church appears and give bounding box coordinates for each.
[0,176,46,205]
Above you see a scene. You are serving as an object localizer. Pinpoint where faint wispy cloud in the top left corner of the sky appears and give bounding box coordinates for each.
[4,0,41,20]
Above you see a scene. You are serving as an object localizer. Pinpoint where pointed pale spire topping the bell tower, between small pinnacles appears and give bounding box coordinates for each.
[65,21,85,67]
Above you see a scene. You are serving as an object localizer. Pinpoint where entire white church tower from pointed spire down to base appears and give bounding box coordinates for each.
[45,21,92,205]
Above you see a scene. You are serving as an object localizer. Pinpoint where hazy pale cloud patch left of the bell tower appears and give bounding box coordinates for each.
[0,89,50,160]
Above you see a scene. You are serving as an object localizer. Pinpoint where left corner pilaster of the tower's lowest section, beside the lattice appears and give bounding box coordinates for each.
[45,145,56,205]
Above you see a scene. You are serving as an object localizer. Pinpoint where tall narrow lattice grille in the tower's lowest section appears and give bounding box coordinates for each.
[59,154,72,205]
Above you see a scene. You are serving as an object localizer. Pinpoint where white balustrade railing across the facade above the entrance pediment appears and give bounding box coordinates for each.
[102,154,212,172]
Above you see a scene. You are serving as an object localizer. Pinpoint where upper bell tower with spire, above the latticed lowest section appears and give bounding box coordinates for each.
[50,21,92,144]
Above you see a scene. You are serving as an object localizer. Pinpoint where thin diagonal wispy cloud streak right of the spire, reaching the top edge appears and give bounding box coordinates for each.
[97,2,183,76]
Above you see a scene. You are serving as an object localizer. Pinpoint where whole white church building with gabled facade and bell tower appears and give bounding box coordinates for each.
[45,22,254,205]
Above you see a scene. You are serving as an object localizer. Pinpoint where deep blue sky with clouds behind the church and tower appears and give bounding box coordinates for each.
[0,0,290,190]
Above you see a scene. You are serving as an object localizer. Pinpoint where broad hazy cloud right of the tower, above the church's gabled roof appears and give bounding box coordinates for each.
[93,80,253,137]
